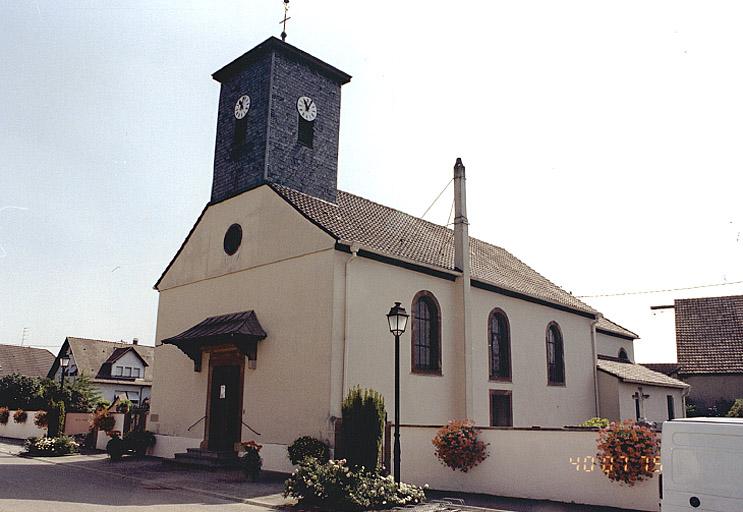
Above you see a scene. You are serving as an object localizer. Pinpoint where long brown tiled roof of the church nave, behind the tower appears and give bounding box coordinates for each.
[271,185,600,316]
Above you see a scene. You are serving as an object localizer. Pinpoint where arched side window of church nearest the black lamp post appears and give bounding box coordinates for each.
[411,291,441,373]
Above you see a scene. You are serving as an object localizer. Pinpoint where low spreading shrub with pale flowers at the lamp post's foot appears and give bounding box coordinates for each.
[284,458,425,512]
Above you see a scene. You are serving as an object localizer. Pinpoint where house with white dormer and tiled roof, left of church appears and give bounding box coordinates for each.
[48,337,154,405]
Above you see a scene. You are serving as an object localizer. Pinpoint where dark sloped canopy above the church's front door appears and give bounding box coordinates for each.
[162,310,266,372]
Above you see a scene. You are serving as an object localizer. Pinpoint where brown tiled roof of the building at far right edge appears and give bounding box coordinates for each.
[674,295,743,374]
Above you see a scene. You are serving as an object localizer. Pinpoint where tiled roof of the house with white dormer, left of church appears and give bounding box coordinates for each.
[49,337,155,382]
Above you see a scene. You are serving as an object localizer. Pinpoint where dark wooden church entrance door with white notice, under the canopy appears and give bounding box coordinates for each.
[206,350,245,451]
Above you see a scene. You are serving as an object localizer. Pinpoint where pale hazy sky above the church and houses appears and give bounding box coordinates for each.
[0,0,743,362]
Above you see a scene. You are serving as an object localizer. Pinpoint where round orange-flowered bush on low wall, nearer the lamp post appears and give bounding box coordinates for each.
[432,420,488,473]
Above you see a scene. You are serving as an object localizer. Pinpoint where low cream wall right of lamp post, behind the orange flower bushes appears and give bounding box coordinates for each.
[400,426,660,511]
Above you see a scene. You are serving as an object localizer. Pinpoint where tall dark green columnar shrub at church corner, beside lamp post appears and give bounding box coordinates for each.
[341,386,384,471]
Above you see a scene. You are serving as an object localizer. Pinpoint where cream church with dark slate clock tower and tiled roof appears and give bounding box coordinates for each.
[149,38,685,470]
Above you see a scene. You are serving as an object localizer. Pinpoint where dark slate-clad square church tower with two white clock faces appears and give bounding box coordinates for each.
[211,37,351,203]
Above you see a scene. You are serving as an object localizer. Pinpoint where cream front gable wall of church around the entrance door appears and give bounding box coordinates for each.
[150,187,335,450]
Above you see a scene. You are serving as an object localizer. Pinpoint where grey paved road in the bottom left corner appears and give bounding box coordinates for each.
[0,453,270,512]
